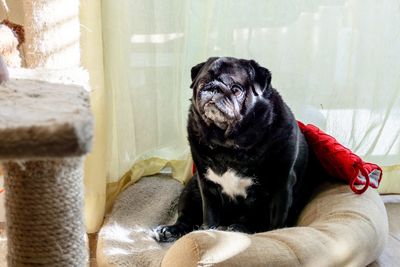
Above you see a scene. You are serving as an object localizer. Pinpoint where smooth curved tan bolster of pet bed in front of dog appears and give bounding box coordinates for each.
[162,185,388,267]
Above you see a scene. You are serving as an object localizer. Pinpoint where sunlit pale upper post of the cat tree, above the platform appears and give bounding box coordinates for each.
[22,0,80,69]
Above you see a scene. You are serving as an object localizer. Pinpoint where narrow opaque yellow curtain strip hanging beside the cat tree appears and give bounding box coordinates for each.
[80,0,107,233]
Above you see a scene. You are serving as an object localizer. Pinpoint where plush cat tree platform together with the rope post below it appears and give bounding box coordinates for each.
[0,80,92,266]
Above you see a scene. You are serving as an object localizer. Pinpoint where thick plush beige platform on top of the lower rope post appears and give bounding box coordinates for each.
[0,79,93,159]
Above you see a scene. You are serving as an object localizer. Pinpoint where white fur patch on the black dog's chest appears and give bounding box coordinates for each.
[206,169,253,199]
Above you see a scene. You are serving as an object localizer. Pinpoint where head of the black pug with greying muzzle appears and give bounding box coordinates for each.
[190,57,271,132]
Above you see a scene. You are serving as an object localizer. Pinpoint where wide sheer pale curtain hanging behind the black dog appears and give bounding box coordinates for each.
[102,0,400,206]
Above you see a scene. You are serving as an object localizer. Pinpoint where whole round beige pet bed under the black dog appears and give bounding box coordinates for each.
[97,177,388,267]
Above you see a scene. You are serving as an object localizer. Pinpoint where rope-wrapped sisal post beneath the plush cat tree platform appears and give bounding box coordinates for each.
[4,158,86,266]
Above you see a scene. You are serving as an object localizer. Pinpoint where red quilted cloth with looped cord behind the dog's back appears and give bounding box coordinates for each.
[192,121,382,194]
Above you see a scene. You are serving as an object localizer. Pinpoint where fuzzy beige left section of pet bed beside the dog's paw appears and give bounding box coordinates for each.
[97,176,183,267]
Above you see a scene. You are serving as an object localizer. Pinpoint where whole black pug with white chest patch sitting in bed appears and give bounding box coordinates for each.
[154,57,318,242]
